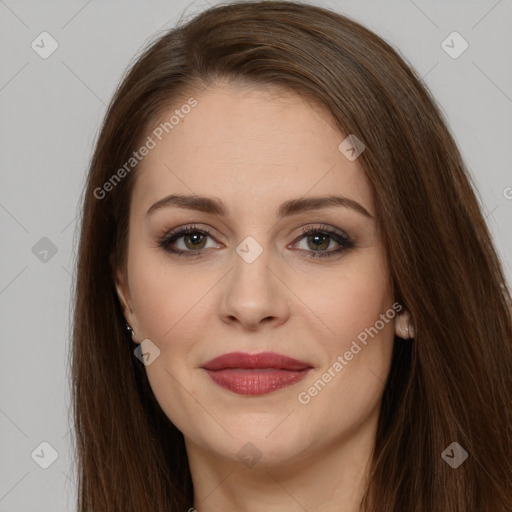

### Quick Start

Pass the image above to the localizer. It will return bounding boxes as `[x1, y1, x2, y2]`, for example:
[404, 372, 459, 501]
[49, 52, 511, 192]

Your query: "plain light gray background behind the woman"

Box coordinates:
[0, 0, 512, 512]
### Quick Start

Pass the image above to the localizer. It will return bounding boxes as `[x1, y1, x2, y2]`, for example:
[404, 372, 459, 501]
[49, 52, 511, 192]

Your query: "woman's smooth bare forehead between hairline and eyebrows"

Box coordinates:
[133, 85, 373, 218]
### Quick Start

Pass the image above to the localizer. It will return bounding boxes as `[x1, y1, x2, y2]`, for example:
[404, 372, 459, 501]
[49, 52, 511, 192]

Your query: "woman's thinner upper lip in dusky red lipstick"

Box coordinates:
[202, 352, 312, 371]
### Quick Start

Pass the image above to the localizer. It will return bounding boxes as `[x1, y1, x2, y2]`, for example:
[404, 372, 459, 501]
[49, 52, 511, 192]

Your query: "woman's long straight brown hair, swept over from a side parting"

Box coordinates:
[71, 1, 512, 512]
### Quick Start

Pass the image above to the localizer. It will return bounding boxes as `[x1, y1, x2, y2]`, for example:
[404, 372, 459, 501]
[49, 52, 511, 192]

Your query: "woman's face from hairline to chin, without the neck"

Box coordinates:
[116, 85, 395, 465]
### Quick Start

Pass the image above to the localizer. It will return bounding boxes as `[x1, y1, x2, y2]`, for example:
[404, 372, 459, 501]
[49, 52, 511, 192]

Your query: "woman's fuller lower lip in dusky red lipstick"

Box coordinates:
[206, 368, 311, 395]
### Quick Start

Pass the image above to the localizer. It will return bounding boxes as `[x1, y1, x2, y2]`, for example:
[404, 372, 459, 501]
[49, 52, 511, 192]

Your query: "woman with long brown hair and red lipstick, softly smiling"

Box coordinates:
[72, 1, 512, 512]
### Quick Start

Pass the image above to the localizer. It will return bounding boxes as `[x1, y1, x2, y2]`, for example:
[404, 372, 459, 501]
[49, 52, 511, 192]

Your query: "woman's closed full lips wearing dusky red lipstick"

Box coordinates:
[202, 352, 313, 395]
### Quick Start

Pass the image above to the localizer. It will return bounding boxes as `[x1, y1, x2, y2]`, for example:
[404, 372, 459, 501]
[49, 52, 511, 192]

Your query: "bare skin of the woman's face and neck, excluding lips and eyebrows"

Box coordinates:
[116, 84, 412, 512]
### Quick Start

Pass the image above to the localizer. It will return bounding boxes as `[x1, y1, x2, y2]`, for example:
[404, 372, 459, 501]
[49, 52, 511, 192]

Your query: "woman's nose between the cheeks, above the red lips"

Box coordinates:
[219, 245, 291, 330]
